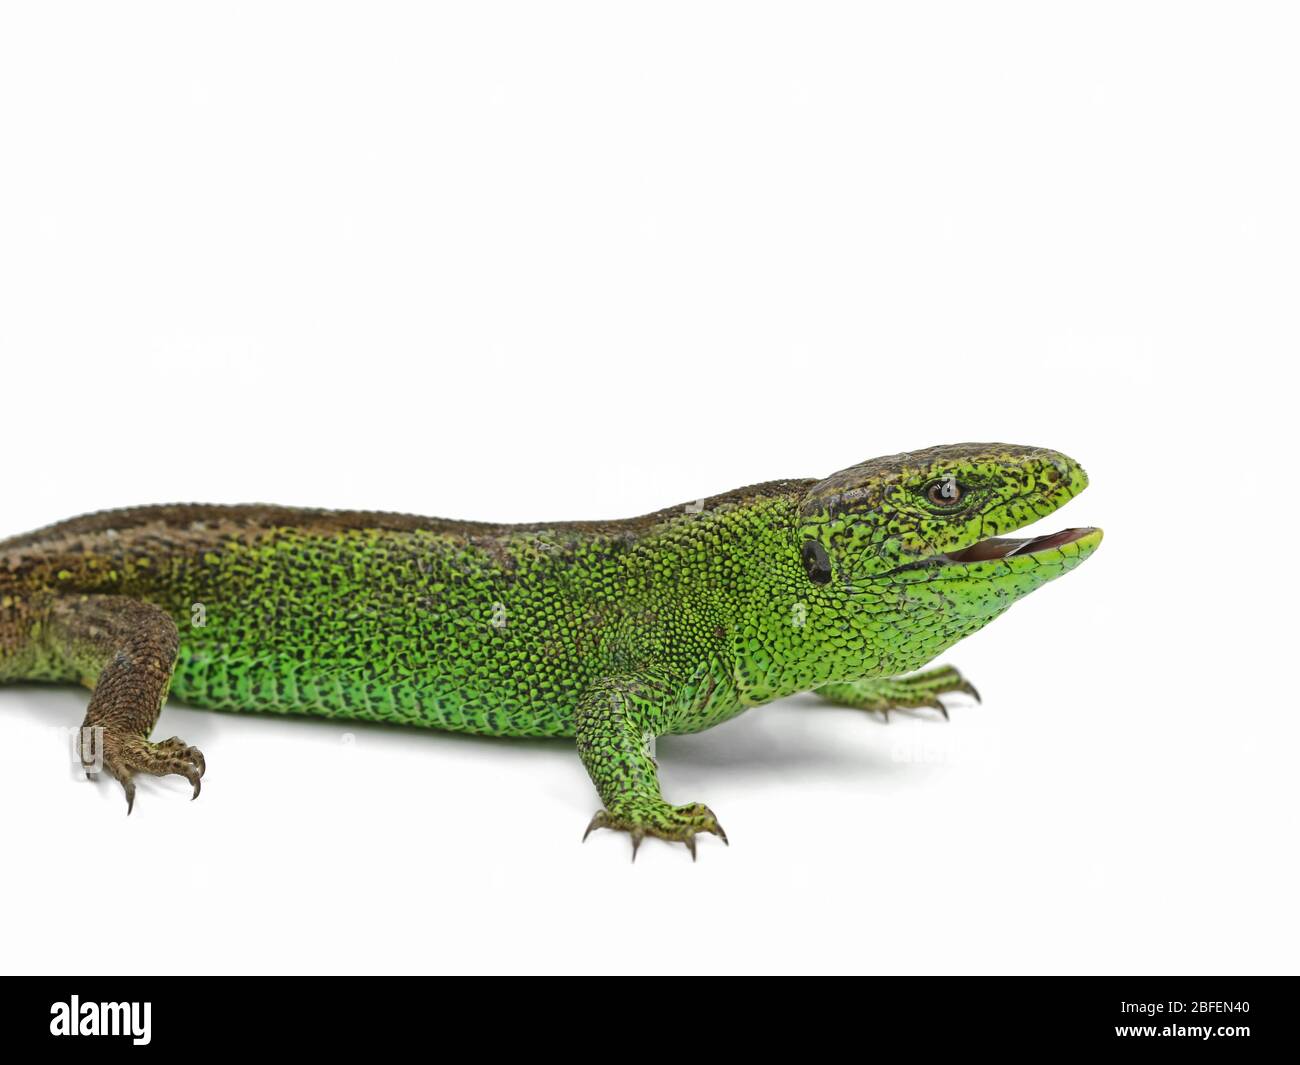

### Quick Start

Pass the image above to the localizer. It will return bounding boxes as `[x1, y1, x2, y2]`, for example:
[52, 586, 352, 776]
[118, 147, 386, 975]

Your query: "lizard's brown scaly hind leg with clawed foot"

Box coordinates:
[49, 596, 204, 813]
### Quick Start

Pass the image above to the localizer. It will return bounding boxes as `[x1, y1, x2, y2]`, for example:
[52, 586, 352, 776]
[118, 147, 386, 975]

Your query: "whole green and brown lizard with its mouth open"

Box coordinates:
[0, 443, 1101, 856]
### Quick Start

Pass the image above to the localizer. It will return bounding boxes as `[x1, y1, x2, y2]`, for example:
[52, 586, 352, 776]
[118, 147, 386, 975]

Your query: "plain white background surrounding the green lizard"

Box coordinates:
[0, 3, 1300, 973]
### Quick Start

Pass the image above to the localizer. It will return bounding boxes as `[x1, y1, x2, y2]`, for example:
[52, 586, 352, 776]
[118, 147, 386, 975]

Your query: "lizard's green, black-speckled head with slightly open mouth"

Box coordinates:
[798, 443, 1101, 667]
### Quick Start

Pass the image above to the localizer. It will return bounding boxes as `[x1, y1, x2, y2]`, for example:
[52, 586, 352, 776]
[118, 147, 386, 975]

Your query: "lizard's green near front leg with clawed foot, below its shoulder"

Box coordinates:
[575, 672, 727, 861]
